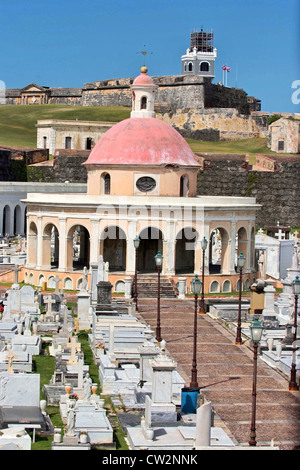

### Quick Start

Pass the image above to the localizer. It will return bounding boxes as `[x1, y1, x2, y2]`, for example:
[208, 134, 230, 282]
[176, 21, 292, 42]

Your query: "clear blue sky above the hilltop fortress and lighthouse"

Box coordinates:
[0, 0, 300, 113]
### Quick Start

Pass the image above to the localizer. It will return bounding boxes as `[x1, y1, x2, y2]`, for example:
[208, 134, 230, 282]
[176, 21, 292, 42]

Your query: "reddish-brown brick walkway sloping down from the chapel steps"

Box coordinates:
[138, 299, 300, 450]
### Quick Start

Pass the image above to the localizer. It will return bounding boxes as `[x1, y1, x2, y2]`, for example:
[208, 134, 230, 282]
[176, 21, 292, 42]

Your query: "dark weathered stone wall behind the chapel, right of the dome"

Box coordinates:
[197, 153, 300, 228]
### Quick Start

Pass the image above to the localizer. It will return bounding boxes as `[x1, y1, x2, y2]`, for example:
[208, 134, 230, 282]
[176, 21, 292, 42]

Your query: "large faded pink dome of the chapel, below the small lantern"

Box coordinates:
[84, 118, 199, 167]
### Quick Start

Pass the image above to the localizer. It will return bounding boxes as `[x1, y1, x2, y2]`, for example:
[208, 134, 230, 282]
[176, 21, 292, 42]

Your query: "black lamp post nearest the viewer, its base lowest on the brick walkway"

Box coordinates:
[249, 317, 264, 446]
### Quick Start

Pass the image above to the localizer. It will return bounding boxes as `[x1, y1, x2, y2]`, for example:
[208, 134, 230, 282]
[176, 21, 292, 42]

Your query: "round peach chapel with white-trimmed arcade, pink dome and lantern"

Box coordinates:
[25, 68, 260, 292]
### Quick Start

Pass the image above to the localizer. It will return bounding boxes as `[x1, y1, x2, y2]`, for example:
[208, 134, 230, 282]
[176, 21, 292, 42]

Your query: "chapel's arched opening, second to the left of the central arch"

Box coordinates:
[67, 225, 90, 271]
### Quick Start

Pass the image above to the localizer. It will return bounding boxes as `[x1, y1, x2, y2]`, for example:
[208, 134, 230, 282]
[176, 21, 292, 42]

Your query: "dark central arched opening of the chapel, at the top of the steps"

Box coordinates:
[138, 227, 163, 273]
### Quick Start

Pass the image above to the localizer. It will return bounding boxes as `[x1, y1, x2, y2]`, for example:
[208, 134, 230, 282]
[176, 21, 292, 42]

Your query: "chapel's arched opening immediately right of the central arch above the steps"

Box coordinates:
[175, 227, 198, 274]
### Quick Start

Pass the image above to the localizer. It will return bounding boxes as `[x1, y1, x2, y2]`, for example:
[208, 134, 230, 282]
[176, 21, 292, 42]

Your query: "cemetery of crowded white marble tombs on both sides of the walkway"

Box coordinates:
[0, 221, 300, 451]
